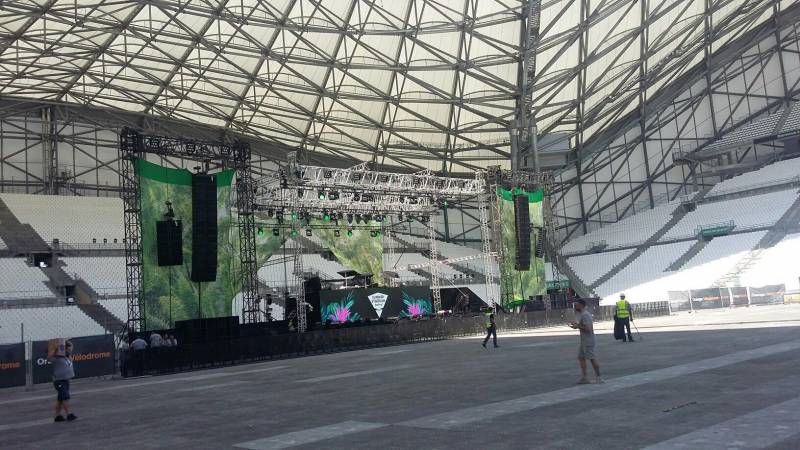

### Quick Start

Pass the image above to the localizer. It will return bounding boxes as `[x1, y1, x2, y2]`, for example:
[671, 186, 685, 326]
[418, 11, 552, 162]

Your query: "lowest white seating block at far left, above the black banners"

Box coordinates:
[0, 306, 105, 344]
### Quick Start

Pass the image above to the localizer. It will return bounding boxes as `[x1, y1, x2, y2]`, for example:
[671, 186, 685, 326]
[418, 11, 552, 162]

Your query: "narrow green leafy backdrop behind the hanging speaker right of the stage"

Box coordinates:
[497, 188, 547, 306]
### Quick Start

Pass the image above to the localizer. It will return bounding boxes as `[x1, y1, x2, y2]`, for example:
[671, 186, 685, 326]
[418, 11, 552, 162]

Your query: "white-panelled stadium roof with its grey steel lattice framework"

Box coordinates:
[0, 0, 800, 250]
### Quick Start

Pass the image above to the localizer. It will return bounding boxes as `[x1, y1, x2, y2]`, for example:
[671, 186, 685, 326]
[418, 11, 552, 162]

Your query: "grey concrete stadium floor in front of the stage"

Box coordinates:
[0, 306, 800, 450]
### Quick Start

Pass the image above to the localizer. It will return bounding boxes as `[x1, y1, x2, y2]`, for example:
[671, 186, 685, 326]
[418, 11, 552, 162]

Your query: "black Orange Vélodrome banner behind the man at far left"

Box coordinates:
[33, 334, 114, 383]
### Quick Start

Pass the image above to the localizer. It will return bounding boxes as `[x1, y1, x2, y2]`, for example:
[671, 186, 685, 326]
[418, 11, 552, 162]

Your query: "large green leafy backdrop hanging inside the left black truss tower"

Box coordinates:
[136, 160, 283, 330]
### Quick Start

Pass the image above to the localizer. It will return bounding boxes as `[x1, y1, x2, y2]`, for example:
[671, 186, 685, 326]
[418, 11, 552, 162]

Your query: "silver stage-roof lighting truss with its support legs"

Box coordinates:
[254, 153, 494, 322]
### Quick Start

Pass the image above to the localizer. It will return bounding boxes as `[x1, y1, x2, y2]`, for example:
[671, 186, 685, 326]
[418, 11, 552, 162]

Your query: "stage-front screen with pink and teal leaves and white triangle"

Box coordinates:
[320, 287, 433, 323]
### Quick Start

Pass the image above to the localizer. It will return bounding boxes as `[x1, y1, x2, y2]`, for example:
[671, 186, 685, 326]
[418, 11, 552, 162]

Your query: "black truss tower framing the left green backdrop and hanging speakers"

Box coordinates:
[119, 128, 260, 331]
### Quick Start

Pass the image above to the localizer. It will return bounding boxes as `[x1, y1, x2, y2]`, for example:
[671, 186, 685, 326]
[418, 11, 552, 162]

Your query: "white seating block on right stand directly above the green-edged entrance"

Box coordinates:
[659, 190, 797, 242]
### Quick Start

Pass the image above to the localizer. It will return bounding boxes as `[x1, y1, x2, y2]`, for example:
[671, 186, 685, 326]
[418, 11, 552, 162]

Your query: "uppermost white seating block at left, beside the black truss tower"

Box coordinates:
[0, 194, 125, 244]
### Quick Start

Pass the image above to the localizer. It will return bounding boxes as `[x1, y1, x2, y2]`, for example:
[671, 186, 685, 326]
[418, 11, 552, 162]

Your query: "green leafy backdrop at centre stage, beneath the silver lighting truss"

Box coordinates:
[311, 219, 383, 284]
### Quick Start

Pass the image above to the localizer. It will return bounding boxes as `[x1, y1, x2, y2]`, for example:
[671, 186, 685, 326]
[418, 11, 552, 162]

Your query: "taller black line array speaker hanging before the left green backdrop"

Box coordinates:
[192, 174, 217, 282]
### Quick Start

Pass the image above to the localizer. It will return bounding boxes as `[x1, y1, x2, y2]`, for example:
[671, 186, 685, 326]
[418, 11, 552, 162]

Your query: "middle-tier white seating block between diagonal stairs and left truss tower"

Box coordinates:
[61, 256, 127, 295]
